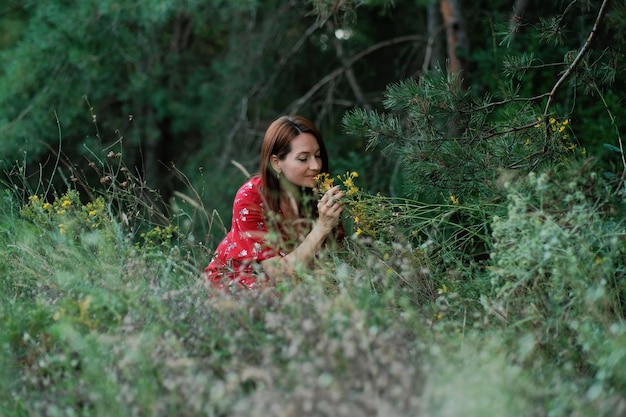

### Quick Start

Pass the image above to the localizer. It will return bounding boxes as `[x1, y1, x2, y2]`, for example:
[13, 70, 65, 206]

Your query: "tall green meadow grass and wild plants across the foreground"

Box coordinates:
[0, 154, 626, 417]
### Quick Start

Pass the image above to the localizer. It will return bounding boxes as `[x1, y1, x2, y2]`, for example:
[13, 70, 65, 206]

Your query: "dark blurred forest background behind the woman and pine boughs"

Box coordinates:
[0, 0, 625, 245]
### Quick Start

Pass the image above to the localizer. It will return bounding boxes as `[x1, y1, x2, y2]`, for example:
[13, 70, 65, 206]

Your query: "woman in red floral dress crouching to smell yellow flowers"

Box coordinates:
[205, 116, 343, 288]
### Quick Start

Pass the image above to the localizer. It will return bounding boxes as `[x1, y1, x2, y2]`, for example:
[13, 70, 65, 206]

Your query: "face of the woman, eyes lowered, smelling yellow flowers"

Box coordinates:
[272, 133, 322, 188]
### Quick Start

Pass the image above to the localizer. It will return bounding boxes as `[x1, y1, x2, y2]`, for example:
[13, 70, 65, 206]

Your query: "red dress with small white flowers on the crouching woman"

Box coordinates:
[204, 176, 285, 288]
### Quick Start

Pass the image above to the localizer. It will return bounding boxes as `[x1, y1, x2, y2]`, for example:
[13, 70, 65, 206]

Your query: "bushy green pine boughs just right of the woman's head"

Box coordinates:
[344, 66, 588, 202]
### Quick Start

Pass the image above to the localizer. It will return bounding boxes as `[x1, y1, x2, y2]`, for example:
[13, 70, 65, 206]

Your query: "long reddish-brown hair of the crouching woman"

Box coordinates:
[260, 116, 329, 213]
